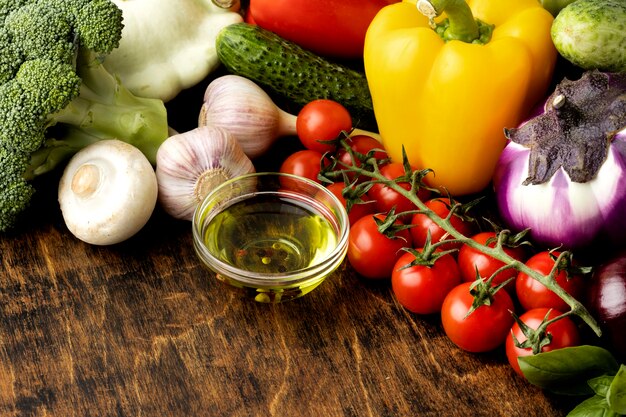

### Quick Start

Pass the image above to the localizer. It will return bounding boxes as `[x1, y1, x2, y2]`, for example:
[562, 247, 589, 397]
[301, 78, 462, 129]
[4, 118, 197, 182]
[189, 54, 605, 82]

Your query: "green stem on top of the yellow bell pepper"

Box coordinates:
[417, 0, 480, 43]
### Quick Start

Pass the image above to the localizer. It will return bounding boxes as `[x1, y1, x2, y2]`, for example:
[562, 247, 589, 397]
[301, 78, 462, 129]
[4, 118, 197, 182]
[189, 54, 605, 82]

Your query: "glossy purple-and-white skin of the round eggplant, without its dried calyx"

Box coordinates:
[493, 70, 626, 255]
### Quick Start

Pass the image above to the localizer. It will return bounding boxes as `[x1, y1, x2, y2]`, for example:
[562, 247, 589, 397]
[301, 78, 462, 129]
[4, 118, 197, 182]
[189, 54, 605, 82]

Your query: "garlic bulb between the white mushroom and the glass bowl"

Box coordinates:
[156, 126, 255, 220]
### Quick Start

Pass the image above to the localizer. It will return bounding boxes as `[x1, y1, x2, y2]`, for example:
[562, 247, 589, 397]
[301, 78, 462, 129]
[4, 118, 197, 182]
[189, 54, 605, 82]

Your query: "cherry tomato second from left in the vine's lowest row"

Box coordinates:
[391, 252, 461, 314]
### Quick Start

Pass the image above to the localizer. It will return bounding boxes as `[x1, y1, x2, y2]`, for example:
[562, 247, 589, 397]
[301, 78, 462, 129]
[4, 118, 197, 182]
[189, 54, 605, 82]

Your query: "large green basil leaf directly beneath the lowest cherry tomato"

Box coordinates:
[518, 345, 619, 395]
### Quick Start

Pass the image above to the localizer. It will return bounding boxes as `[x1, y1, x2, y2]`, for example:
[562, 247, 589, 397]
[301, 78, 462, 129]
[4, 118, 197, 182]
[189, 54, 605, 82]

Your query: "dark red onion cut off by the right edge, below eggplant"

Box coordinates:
[587, 250, 626, 360]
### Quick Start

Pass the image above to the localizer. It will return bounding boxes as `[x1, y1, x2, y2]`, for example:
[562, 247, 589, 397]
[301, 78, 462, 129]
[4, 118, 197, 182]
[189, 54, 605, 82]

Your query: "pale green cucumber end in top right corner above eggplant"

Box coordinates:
[551, 0, 626, 72]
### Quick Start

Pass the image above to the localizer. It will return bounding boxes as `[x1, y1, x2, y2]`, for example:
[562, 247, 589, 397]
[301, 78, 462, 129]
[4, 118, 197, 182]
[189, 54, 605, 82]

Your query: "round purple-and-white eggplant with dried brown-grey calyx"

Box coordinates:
[493, 71, 626, 255]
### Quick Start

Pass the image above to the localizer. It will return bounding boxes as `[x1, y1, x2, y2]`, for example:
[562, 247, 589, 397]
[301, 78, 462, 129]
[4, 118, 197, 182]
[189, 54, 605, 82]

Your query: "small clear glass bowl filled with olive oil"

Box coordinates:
[192, 172, 349, 303]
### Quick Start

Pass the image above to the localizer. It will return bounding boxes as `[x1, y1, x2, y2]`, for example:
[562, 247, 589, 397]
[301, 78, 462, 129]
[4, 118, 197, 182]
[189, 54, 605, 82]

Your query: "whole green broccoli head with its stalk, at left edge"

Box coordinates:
[0, 0, 168, 231]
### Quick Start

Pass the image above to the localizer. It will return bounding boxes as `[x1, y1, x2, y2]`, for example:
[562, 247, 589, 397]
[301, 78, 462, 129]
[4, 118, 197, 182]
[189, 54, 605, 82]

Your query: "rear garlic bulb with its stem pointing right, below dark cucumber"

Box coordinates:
[198, 74, 296, 159]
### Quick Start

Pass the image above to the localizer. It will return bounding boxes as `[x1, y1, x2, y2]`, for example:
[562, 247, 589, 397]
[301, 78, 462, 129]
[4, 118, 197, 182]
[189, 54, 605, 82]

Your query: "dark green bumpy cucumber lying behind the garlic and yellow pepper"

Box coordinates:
[215, 23, 377, 130]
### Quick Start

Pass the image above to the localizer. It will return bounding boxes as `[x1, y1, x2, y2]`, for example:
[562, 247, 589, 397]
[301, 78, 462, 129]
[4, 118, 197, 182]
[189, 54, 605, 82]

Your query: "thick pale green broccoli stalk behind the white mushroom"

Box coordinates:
[24, 50, 168, 180]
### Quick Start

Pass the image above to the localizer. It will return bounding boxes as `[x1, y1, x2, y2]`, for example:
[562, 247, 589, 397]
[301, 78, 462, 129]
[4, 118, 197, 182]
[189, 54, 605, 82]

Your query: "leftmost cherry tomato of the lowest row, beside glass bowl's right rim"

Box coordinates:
[348, 214, 411, 279]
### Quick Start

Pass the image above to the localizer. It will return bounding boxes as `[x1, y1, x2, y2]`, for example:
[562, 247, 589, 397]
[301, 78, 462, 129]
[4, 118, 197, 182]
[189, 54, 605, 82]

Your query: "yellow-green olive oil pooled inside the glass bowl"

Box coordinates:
[204, 194, 338, 274]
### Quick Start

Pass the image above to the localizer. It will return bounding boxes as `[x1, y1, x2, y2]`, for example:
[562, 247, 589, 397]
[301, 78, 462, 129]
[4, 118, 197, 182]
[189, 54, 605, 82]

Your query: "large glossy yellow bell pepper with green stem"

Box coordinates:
[364, 0, 557, 195]
